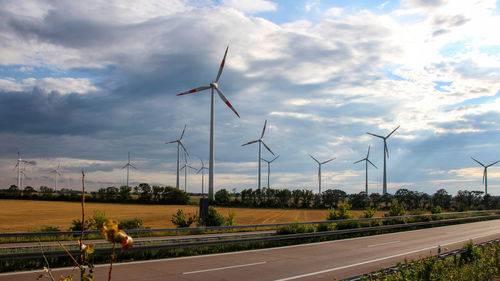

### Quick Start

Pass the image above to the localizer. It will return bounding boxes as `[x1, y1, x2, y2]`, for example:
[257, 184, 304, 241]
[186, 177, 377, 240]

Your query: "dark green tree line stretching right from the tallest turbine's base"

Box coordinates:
[213, 188, 500, 211]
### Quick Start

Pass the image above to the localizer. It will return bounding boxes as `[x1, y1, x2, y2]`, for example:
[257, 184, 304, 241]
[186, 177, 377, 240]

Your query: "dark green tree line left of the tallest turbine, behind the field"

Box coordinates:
[0, 183, 190, 205]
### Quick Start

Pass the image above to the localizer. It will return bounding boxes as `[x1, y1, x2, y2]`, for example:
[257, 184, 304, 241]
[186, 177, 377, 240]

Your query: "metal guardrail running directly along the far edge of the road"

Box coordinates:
[0, 214, 500, 260]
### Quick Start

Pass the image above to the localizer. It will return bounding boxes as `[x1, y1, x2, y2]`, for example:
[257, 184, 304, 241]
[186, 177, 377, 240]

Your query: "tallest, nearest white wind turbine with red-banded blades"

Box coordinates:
[177, 46, 240, 200]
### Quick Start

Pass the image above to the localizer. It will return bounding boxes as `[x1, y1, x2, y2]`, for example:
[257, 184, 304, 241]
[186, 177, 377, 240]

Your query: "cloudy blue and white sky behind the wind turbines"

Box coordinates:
[0, 0, 500, 195]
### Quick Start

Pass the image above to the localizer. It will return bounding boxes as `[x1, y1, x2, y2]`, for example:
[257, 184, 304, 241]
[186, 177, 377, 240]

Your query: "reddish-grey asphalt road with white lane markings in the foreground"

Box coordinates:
[0, 220, 500, 281]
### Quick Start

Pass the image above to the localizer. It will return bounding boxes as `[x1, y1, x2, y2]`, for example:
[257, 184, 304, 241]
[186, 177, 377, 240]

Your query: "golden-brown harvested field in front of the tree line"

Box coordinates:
[0, 199, 383, 233]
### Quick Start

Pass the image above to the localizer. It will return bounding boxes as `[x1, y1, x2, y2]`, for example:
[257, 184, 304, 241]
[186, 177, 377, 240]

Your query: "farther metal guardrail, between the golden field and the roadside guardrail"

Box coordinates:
[0, 210, 500, 238]
